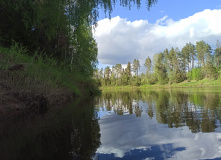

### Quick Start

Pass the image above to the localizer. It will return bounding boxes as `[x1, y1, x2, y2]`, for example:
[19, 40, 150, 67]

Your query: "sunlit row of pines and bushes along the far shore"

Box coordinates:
[94, 40, 221, 86]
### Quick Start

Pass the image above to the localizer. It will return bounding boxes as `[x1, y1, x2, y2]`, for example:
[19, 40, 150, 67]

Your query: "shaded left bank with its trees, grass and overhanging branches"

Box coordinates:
[0, 0, 157, 110]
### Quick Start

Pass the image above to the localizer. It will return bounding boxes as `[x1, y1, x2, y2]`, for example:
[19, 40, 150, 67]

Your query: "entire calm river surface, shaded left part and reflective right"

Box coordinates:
[0, 88, 221, 160]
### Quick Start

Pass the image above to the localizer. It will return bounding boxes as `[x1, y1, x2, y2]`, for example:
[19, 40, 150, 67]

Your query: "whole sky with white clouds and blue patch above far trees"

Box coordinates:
[94, 0, 221, 68]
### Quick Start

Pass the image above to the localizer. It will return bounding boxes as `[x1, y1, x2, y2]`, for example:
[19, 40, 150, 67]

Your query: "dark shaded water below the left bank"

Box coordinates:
[0, 99, 100, 160]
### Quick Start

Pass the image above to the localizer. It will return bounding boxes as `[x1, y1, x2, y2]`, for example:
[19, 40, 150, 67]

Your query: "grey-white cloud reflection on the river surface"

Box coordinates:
[96, 115, 221, 160]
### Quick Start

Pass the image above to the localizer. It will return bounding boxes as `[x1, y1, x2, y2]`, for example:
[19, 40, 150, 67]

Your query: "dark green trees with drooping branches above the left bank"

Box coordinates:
[0, 0, 157, 75]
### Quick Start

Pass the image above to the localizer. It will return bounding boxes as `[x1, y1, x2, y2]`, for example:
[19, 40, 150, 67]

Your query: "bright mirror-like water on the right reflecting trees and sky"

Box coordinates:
[96, 89, 221, 160]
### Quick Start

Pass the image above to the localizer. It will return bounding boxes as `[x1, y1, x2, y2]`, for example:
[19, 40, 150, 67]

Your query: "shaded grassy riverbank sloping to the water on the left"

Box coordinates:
[0, 45, 97, 118]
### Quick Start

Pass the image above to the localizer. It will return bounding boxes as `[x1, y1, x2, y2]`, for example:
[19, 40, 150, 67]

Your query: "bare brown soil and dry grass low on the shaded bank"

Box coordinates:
[0, 68, 74, 119]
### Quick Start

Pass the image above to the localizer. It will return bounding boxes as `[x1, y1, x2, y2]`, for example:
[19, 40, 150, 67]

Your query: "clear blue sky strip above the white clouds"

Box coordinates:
[99, 0, 221, 23]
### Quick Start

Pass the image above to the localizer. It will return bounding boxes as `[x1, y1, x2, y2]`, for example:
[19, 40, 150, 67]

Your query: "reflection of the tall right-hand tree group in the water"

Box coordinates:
[148, 90, 219, 133]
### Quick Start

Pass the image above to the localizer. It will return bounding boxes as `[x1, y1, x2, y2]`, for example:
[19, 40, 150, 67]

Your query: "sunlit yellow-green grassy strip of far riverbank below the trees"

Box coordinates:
[100, 79, 221, 90]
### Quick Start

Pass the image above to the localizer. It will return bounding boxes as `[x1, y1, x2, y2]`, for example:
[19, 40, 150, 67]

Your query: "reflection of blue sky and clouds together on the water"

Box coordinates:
[94, 89, 221, 160]
